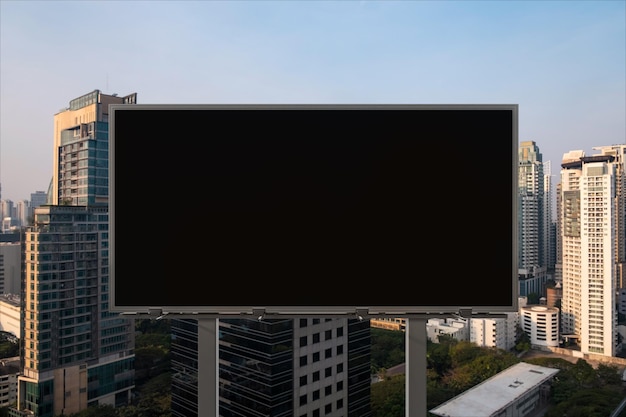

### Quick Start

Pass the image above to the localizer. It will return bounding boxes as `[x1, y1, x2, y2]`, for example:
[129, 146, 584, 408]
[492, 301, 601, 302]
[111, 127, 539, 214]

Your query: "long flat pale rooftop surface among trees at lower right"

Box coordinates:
[430, 362, 559, 417]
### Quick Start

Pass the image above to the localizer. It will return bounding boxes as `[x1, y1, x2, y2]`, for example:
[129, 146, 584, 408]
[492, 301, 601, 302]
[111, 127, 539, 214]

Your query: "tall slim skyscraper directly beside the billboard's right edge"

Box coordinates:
[518, 141, 550, 296]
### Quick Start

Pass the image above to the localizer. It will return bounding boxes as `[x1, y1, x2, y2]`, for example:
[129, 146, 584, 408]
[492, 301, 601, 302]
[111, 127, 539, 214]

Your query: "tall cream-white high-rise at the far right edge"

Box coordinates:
[560, 145, 626, 356]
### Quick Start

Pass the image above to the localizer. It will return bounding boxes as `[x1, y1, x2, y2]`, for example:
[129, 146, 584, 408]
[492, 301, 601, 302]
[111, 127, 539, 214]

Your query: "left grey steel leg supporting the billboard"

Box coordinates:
[198, 318, 219, 417]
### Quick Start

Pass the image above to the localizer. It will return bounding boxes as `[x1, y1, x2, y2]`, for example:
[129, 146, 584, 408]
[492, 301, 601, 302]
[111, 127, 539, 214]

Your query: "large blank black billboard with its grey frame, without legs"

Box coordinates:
[109, 104, 518, 316]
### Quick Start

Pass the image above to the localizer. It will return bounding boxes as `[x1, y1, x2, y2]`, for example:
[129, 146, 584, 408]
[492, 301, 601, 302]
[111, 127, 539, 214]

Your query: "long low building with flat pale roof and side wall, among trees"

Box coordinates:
[429, 362, 559, 417]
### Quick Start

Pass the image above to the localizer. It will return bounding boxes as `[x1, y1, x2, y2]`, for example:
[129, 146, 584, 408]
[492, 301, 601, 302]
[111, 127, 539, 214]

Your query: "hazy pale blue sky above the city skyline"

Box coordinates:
[0, 0, 626, 201]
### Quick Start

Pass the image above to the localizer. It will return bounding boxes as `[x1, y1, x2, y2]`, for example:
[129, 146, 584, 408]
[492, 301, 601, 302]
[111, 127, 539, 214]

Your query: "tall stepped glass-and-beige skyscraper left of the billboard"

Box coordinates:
[10, 90, 136, 417]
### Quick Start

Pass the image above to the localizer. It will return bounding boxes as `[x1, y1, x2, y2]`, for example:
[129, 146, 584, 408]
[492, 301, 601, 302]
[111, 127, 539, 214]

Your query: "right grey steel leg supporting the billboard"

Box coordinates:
[405, 317, 427, 417]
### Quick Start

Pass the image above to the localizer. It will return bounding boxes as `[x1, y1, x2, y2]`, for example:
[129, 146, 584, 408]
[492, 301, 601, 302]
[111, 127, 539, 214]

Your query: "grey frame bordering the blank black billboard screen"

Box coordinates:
[109, 104, 519, 319]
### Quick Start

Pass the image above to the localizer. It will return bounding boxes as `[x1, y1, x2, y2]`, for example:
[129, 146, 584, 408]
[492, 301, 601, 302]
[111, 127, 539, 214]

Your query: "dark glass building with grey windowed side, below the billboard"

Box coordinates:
[172, 317, 371, 417]
